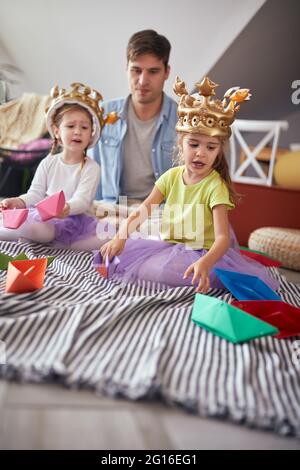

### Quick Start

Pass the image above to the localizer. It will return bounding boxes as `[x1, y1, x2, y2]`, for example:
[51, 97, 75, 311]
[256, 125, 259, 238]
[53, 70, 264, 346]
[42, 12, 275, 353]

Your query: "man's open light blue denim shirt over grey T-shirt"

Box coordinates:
[89, 94, 177, 202]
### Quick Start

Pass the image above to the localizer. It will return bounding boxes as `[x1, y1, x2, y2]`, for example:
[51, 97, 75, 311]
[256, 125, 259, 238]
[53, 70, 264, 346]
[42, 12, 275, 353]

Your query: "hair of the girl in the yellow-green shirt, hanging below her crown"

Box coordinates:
[174, 132, 240, 204]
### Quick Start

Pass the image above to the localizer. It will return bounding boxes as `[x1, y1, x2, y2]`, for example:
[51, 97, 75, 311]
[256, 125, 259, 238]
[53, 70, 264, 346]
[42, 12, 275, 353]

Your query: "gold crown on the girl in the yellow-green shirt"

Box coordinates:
[173, 77, 251, 139]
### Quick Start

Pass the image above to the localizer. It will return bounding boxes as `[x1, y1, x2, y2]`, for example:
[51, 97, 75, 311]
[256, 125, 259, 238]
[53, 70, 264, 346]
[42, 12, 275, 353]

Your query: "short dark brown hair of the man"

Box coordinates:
[127, 29, 171, 68]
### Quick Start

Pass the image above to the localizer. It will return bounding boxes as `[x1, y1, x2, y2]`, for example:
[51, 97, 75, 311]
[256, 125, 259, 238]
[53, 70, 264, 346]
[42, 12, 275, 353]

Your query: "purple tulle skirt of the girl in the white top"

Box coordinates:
[27, 208, 98, 246]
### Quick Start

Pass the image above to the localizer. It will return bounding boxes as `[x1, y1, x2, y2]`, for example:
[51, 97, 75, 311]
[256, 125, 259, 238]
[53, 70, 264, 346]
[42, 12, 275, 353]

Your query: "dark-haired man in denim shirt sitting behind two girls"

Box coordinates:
[92, 30, 177, 202]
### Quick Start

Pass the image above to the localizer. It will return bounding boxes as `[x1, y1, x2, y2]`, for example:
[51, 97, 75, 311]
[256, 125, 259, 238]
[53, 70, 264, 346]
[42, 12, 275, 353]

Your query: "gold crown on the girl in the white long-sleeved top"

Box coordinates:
[46, 83, 119, 147]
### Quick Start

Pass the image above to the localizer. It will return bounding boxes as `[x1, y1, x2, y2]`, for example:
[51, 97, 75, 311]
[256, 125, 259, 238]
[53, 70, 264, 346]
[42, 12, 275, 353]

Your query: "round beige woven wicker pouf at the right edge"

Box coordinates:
[248, 227, 300, 271]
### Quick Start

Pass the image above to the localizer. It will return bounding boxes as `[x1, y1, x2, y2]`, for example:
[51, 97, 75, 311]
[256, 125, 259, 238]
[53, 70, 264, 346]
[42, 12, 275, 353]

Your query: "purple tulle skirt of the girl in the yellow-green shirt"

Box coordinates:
[112, 239, 279, 289]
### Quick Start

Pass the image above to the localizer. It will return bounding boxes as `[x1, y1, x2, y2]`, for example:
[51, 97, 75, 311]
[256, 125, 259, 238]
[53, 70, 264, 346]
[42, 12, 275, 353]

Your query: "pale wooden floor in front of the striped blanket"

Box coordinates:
[0, 270, 300, 450]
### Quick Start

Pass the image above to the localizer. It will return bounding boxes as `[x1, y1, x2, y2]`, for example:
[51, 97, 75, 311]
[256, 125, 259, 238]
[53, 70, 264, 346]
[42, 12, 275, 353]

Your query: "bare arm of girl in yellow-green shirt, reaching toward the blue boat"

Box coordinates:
[183, 204, 230, 294]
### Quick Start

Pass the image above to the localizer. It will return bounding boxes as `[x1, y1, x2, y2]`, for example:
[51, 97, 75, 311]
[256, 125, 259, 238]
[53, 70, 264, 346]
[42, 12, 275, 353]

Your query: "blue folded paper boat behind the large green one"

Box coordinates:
[214, 268, 281, 300]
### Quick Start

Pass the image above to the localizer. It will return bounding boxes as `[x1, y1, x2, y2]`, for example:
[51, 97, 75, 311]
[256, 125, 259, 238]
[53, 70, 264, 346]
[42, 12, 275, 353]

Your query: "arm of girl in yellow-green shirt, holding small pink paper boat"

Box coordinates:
[100, 186, 165, 260]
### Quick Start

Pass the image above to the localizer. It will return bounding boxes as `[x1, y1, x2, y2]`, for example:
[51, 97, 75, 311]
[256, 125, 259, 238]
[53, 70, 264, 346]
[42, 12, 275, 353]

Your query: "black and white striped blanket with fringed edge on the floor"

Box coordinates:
[0, 242, 300, 436]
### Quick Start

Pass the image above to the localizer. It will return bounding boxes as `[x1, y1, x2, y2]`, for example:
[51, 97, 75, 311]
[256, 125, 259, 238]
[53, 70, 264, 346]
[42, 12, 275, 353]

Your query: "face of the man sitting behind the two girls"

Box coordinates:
[127, 54, 170, 104]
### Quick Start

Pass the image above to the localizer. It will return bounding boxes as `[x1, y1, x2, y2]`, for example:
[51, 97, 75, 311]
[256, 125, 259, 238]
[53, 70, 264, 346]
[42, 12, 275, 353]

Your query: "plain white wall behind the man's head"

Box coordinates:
[0, 0, 265, 99]
